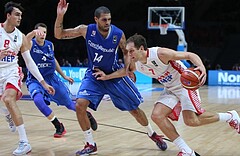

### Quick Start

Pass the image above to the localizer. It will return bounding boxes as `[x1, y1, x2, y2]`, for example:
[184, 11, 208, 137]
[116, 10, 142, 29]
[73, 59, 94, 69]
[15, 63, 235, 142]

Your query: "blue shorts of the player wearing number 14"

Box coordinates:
[77, 71, 143, 111]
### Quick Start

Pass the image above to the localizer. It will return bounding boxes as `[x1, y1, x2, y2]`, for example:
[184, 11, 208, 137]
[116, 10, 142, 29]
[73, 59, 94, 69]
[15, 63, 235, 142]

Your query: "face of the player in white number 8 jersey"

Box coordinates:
[7, 7, 22, 27]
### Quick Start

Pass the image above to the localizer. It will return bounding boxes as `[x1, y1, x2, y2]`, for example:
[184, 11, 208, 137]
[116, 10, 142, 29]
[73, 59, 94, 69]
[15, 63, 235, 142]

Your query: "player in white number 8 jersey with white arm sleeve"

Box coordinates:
[0, 2, 55, 155]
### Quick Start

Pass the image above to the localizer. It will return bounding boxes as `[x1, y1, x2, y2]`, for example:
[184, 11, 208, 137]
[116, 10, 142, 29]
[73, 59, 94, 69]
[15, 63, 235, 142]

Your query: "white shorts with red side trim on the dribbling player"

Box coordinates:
[156, 88, 205, 120]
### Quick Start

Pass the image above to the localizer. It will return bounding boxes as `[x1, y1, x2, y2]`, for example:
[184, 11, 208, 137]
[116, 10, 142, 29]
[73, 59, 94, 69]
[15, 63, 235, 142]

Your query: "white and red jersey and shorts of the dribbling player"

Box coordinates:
[136, 47, 205, 120]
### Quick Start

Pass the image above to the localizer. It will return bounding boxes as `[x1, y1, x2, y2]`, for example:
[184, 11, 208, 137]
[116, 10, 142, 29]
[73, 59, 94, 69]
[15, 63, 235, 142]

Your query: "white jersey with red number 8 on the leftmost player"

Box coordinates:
[0, 23, 23, 68]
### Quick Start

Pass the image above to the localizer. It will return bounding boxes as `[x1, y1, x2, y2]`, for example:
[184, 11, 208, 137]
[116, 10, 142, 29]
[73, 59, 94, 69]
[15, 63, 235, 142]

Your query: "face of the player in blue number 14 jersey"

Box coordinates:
[95, 13, 111, 32]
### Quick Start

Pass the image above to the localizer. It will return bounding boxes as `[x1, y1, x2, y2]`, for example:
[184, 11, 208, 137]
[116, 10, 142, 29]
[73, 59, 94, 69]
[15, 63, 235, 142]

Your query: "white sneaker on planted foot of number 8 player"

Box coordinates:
[13, 141, 32, 156]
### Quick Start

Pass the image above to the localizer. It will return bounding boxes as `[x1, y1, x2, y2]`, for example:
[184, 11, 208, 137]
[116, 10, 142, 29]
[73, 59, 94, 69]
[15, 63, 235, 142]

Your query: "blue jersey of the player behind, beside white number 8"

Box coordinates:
[28, 39, 56, 79]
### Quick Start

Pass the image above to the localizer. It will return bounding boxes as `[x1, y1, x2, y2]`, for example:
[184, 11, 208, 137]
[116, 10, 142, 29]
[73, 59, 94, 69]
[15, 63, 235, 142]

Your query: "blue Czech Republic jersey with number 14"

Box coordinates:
[86, 24, 123, 74]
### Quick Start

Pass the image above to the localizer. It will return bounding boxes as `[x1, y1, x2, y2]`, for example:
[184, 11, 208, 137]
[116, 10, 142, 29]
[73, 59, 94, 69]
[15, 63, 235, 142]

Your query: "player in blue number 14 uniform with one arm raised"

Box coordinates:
[54, 0, 167, 155]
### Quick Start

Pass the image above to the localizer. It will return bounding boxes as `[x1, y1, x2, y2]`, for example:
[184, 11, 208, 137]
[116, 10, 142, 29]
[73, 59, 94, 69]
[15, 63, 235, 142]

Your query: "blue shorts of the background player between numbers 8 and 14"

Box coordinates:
[26, 73, 73, 106]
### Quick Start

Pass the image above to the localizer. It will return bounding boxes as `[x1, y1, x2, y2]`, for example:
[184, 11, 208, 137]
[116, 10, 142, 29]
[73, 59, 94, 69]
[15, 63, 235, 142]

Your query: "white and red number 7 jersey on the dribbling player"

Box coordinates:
[135, 47, 187, 91]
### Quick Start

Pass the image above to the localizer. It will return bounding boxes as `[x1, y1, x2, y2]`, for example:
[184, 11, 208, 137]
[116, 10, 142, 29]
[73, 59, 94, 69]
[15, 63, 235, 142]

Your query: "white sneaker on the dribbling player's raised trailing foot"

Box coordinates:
[227, 110, 240, 134]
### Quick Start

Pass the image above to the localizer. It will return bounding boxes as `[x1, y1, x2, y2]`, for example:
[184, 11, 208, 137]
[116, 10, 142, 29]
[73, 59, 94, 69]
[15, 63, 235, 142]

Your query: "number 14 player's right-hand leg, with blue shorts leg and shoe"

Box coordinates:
[108, 76, 167, 150]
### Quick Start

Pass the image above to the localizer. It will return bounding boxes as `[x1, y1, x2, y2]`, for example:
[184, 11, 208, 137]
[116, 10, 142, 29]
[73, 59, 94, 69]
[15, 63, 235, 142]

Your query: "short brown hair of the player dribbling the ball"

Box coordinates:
[126, 34, 147, 50]
